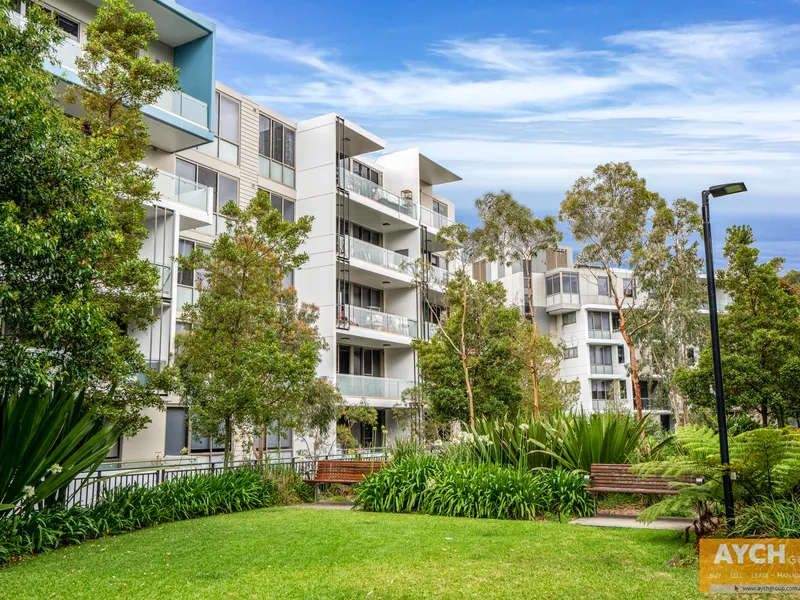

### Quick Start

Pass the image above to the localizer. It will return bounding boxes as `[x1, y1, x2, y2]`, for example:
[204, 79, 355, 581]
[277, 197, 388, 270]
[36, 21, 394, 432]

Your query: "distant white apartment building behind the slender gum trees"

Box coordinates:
[482, 247, 729, 429]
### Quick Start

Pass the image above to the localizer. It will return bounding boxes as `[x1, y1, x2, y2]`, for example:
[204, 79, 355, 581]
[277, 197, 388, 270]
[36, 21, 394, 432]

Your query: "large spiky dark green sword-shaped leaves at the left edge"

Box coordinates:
[0, 382, 120, 513]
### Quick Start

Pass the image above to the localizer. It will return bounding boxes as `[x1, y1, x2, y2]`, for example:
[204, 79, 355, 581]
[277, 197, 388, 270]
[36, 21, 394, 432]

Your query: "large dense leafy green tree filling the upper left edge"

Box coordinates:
[0, 1, 174, 433]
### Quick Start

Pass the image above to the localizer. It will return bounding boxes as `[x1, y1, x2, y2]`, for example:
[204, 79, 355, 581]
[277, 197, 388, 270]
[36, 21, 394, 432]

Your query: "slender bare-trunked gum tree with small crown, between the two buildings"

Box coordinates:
[474, 192, 564, 419]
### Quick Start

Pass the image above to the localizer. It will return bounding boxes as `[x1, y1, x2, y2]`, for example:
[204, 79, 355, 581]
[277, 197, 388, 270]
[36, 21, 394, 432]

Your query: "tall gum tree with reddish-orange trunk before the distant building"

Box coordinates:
[559, 163, 676, 420]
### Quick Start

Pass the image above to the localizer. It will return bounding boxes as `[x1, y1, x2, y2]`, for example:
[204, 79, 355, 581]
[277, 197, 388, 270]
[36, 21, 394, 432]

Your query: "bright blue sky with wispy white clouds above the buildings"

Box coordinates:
[180, 0, 800, 268]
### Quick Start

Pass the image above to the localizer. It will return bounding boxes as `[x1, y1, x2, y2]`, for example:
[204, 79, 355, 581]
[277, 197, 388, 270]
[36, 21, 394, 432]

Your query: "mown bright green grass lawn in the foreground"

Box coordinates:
[0, 508, 703, 600]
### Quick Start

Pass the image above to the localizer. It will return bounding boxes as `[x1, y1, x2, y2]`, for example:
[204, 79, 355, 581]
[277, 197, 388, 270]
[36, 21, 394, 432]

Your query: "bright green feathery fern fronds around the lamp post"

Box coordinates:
[635, 425, 800, 521]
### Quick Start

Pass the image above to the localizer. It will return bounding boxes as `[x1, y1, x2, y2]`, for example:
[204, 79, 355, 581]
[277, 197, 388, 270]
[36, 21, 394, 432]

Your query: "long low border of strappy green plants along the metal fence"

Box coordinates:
[0, 469, 294, 564]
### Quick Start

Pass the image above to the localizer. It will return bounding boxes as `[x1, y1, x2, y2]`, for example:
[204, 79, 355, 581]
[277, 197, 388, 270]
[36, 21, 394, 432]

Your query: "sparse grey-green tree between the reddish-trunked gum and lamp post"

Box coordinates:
[636, 198, 708, 425]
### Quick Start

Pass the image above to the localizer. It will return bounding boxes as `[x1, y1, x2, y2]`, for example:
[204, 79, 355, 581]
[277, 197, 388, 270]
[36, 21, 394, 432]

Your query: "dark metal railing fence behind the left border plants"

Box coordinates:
[61, 448, 386, 507]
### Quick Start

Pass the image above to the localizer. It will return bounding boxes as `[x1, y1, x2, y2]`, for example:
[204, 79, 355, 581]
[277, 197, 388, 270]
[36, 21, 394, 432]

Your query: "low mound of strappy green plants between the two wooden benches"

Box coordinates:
[356, 454, 591, 519]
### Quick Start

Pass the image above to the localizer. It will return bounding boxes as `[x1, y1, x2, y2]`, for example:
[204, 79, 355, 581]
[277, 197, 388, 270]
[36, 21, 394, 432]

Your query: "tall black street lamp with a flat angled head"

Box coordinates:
[703, 182, 747, 529]
